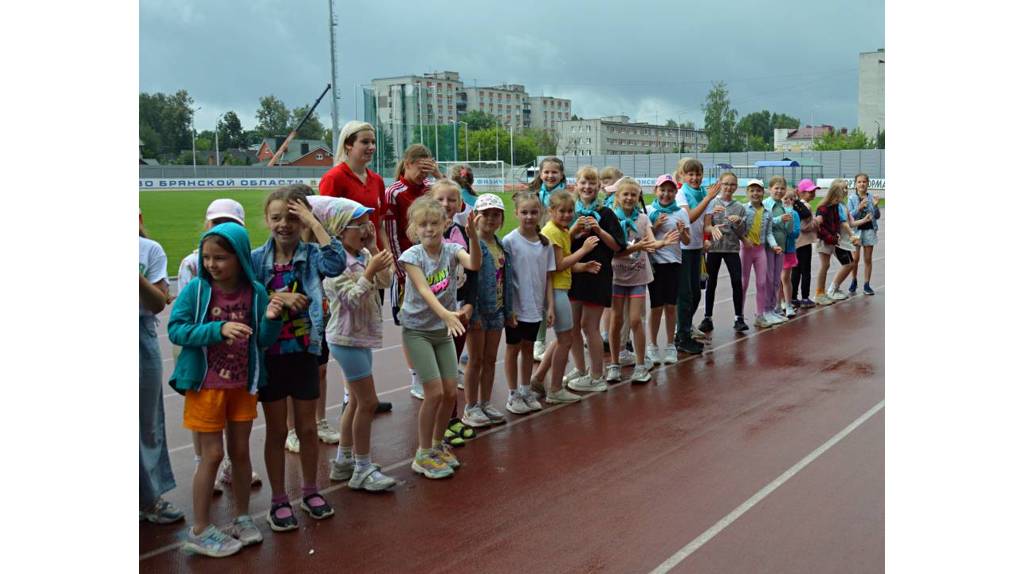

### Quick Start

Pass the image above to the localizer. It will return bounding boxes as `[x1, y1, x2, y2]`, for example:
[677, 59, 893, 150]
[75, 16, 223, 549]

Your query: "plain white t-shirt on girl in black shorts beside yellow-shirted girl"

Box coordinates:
[502, 228, 555, 323]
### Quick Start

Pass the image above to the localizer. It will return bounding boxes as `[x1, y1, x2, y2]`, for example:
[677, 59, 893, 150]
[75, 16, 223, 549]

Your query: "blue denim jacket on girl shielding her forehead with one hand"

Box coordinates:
[252, 236, 345, 355]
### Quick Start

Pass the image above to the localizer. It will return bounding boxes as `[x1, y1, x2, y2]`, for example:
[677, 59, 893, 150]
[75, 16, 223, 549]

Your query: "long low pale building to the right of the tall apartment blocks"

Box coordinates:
[557, 116, 708, 156]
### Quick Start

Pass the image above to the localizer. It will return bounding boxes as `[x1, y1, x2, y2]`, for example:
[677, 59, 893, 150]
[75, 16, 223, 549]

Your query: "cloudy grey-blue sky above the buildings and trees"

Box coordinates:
[139, 0, 885, 136]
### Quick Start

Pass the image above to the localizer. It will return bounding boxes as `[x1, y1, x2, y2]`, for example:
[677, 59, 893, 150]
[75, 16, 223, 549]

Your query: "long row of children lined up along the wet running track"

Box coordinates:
[134, 125, 880, 557]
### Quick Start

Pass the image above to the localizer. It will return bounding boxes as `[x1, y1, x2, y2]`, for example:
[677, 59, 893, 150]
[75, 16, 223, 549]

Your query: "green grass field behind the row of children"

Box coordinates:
[138, 189, 885, 276]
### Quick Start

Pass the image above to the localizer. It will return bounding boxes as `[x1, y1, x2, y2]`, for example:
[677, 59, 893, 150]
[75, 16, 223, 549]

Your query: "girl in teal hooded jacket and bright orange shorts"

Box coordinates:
[167, 223, 283, 558]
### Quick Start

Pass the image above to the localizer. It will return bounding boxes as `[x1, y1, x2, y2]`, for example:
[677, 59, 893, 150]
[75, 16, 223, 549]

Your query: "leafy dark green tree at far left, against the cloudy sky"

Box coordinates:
[138, 90, 194, 157]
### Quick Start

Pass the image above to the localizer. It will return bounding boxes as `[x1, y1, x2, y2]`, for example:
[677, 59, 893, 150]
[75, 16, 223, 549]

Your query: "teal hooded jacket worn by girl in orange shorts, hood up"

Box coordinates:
[167, 223, 282, 395]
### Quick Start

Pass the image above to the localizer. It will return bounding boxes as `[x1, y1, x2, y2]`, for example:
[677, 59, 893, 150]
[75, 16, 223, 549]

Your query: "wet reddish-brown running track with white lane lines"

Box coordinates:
[139, 226, 886, 573]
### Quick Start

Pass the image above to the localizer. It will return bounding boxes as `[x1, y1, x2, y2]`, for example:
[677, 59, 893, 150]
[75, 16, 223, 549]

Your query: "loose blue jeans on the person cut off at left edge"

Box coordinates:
[138, 316, 175, 509]
